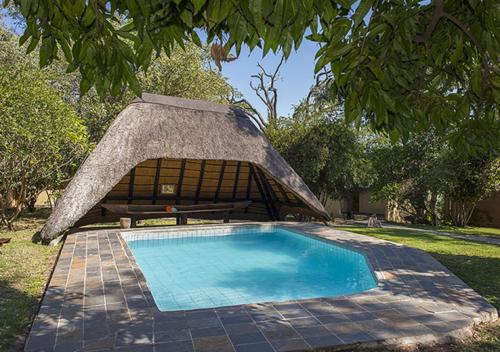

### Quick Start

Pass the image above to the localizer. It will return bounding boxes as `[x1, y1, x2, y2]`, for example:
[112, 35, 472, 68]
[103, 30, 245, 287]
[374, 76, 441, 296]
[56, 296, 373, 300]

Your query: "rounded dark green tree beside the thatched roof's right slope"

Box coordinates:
[266, 104, 371, 199]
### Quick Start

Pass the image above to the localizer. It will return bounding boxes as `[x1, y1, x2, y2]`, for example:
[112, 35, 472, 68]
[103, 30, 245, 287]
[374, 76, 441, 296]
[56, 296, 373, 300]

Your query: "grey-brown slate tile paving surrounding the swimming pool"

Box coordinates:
[25, 223, 497, 352]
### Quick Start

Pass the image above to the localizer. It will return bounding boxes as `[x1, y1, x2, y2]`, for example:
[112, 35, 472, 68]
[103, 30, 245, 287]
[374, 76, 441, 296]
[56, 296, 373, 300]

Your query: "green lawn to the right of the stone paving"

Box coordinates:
[340, 226, 500, 352]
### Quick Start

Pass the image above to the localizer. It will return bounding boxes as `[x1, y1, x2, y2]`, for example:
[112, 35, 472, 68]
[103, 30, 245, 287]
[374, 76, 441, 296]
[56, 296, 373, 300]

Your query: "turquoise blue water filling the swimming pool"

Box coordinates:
[125, 227, 376, 311]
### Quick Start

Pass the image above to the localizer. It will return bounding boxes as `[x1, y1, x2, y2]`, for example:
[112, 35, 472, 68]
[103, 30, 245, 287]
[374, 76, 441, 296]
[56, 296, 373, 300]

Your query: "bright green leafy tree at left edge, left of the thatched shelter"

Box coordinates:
[0, 67, 88, 229]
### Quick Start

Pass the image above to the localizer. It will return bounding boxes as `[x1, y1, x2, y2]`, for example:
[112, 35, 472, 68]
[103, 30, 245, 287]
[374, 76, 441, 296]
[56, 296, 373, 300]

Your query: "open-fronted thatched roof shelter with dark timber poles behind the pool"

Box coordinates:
[41, 94, 329, 240]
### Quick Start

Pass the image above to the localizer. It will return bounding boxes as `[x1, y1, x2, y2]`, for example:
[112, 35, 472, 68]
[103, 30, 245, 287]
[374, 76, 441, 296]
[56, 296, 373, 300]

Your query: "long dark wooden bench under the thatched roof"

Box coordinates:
[101, 201, 251, 227]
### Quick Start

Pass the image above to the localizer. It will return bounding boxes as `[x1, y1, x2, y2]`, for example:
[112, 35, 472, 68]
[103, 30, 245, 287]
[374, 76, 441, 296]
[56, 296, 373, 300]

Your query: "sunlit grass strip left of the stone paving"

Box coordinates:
[0, 211, 59, 351]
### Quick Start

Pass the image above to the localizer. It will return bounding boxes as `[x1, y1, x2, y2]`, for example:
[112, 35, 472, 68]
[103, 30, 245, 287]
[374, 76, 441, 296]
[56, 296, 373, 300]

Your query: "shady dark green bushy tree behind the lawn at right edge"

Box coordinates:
[370, 132, 500, 226]
